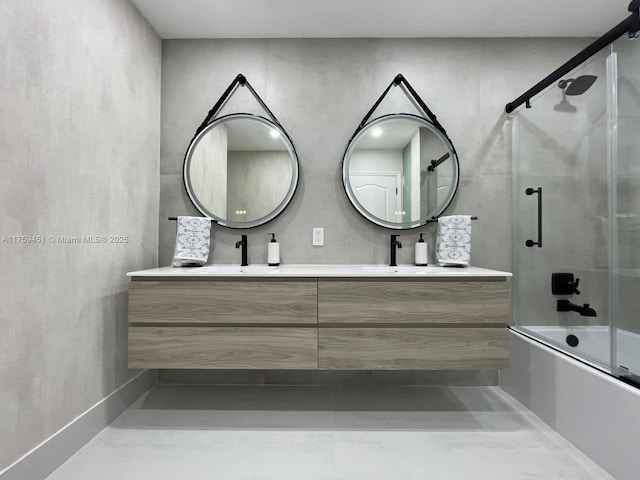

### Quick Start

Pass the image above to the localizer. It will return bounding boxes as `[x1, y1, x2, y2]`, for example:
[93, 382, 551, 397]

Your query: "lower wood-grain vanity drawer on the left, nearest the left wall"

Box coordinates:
[129, 326, 318, 369]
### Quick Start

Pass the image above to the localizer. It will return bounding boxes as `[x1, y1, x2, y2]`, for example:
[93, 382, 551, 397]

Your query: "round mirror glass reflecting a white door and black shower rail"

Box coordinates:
[342, 114, 458, 229]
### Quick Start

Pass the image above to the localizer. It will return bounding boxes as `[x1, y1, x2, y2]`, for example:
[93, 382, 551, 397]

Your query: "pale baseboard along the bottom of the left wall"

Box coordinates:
[0, 370, 157, 480]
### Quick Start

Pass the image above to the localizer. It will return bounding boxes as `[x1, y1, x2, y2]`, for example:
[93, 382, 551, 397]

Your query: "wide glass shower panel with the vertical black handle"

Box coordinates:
[513, 49, 610, 368]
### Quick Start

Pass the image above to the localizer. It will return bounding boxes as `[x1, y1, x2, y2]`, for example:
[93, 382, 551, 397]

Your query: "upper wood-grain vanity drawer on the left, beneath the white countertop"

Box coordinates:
[129, 279, 317, 325]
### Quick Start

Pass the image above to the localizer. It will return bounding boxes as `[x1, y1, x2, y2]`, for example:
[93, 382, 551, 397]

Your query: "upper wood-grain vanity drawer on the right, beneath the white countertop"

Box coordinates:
[318, 279, 510, 325]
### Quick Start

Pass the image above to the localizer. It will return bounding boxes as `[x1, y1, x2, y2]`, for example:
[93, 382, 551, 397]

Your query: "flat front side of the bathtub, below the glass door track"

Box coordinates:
[500, 331, 640, 480]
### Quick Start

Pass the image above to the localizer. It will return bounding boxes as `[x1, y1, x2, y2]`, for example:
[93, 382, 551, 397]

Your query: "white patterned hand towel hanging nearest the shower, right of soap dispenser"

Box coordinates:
[436, 215, 471, 267]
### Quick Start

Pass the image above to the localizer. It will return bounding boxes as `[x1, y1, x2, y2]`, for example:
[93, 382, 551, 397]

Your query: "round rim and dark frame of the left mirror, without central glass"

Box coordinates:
[182, 113, 300, 229]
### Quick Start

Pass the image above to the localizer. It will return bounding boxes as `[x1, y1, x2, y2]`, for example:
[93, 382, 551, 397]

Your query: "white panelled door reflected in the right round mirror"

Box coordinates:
[350, 172, 402, 222]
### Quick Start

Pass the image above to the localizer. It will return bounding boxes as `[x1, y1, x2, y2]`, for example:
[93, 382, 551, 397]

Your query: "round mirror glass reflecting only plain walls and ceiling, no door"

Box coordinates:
[184, 113, 298, 228]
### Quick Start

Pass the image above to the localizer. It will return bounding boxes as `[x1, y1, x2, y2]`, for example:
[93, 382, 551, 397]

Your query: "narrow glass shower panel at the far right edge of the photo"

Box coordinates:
[611, 38, 640, 381]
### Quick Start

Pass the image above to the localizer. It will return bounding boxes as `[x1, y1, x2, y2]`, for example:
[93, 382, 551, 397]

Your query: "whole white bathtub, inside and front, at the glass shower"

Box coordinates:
[499, 327, 640, 480]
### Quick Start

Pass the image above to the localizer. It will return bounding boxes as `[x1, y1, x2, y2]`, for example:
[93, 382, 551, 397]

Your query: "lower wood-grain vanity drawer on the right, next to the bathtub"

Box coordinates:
[318, 327, 508, 370]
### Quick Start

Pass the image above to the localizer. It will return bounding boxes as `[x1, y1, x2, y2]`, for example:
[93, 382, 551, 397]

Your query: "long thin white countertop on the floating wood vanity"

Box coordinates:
[127, 265, 512, 278]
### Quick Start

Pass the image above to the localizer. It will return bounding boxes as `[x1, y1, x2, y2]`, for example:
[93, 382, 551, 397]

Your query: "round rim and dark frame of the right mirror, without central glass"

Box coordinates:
[342, 113, 460, 230]
